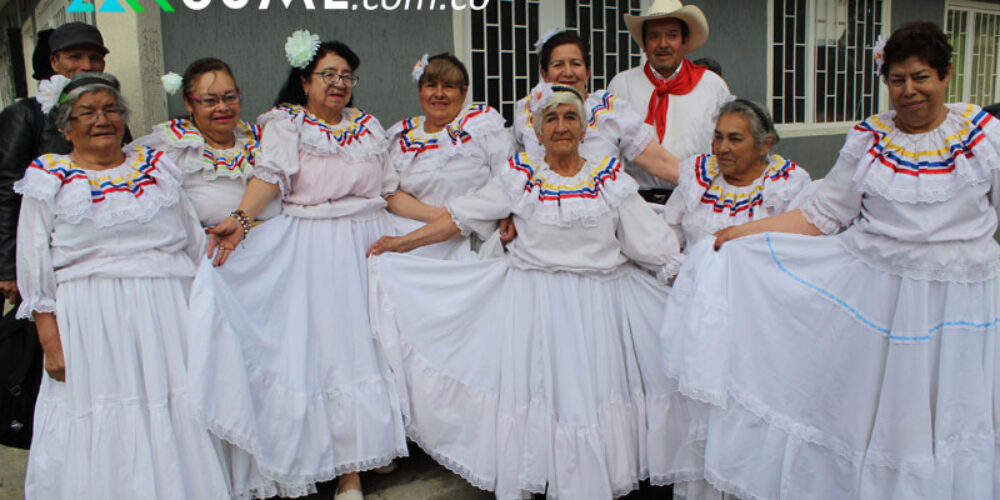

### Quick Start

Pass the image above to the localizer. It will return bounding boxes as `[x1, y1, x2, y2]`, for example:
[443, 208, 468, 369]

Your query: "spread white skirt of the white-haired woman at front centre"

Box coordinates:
[371, 254, 667, 500]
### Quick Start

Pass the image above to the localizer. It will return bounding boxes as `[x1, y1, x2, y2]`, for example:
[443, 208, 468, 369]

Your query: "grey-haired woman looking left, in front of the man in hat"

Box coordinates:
[663, 99, 810, 252]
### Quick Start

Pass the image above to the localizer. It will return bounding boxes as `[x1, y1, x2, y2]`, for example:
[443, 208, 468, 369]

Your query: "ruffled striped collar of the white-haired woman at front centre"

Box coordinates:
[498, 153, 639, 227]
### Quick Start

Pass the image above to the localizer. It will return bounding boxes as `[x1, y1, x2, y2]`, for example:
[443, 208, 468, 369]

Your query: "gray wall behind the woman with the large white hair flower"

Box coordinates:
[162, 6, 454, 128]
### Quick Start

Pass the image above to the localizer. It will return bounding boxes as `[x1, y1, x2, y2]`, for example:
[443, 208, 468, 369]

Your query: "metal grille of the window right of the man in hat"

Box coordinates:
[770, 0, 886, 124]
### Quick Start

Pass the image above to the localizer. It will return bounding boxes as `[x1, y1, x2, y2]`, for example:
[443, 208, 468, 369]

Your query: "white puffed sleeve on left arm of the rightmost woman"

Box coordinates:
[801, 134, 870, 234]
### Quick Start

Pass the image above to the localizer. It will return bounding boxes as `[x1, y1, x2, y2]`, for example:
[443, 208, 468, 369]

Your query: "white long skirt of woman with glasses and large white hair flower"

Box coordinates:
[190, 211, 406, 497]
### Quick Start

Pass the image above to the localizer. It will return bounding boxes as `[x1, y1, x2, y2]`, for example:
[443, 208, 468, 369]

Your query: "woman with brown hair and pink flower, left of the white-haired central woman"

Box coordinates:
[388, 53, 513, 259]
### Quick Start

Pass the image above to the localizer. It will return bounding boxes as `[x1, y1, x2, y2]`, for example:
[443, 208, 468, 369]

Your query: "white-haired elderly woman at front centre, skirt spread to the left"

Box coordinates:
[371, 86, 679, 500]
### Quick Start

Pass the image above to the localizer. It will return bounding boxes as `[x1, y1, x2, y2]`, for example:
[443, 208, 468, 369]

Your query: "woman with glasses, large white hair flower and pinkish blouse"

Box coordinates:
[189, 31, 406, 500]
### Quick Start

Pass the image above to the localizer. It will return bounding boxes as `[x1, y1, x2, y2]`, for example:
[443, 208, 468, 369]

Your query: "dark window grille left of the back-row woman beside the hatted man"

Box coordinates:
[471, 0, 539, 124]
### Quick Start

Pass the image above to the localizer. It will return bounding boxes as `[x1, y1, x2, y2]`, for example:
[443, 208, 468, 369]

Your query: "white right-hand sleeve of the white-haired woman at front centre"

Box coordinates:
[616, 193, 684, 282]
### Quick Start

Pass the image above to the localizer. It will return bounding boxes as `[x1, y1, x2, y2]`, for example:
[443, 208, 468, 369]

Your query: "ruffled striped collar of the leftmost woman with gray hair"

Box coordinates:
[14, 146, 181, 227]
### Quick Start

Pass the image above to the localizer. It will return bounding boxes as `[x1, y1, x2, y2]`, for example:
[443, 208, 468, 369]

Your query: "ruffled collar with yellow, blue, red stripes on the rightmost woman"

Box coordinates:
[845, 104, 1000, 203]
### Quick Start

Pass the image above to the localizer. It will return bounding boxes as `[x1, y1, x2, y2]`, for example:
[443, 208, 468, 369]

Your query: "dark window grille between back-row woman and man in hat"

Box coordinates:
[566, 0, 642, 90]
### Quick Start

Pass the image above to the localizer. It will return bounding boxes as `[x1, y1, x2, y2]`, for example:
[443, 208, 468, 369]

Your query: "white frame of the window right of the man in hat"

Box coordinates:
[766, 0, 892, 137]
